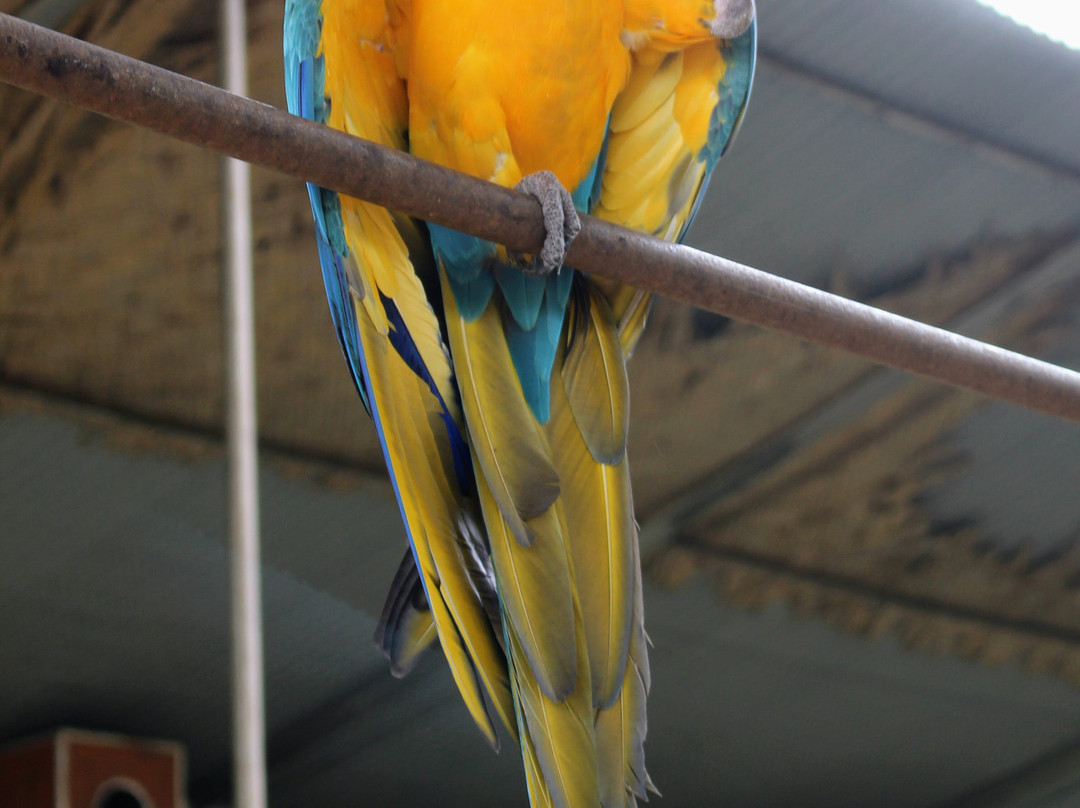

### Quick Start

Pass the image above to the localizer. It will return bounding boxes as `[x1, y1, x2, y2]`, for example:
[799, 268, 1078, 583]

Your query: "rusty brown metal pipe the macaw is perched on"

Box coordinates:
[0, 14, 1080, 421]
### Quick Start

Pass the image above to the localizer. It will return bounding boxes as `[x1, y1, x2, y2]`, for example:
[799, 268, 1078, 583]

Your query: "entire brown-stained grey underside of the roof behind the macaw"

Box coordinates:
[6, 0, 1080, 808]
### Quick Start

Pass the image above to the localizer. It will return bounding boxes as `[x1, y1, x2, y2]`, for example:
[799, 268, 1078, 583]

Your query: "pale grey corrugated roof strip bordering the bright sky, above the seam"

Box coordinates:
[758, 0, 1080, 173]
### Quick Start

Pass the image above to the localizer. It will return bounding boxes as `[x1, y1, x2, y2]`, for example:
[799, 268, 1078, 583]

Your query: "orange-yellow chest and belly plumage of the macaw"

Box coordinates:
[402, 0, 630, 188]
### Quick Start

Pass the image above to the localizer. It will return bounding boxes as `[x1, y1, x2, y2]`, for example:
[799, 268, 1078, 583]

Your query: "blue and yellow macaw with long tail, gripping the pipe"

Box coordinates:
[285, 0, 755, 808]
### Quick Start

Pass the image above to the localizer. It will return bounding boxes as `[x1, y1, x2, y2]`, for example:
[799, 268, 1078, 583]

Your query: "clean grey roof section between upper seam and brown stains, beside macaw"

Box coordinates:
[690, 63, 1080, 289]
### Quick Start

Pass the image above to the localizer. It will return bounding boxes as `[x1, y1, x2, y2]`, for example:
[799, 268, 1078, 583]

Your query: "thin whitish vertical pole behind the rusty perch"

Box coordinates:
[218, 0, 267, 808]
